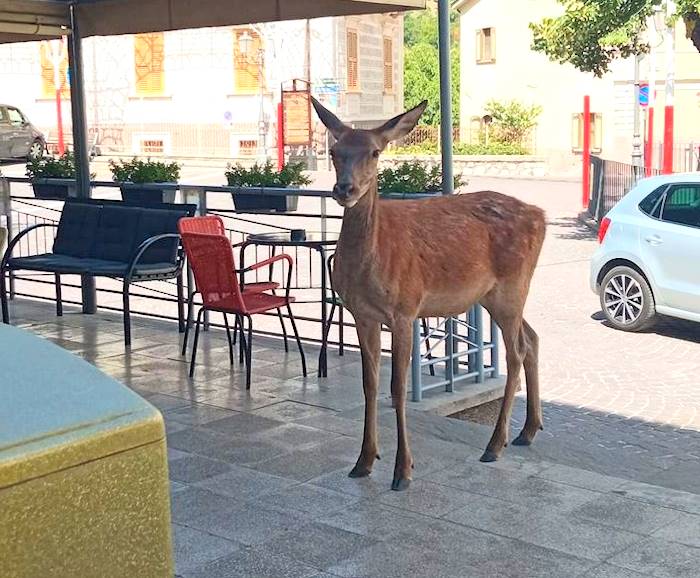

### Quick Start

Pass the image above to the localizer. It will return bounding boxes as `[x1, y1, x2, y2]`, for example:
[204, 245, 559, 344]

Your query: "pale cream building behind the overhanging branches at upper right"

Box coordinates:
[456, 0, 700, 171]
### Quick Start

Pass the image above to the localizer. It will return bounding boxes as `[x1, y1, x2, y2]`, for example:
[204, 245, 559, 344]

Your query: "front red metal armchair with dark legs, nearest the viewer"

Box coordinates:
[179, 217, 306, 389]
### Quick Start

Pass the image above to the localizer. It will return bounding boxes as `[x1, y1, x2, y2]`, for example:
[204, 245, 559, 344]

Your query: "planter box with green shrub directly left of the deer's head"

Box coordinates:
[226, 161, 311, 212]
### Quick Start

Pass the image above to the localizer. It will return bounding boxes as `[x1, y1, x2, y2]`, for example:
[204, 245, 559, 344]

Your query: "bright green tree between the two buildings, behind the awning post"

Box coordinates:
[404, 2, 459, 126]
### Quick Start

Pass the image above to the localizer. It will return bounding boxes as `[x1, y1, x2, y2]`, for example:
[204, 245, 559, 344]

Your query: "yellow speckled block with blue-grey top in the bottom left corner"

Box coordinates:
[0, 326, 173, 578]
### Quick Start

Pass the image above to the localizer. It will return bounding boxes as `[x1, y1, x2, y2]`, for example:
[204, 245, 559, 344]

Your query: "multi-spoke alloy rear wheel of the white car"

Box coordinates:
[599, 265, 656, 331]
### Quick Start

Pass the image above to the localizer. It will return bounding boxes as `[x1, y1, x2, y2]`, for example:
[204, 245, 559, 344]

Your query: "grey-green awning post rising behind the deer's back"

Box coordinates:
[438, 0, 454, 195]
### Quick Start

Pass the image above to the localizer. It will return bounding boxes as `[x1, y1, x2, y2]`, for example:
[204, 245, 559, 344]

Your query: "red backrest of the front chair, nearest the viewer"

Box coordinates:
[180, 228, 246, 313]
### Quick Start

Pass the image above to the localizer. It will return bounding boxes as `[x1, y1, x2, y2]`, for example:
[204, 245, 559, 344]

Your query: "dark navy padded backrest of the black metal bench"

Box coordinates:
[53, 200, 196, 264]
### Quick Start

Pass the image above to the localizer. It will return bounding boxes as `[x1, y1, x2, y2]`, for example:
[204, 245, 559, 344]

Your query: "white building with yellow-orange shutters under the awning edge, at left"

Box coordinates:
[0, 15, 403, 157]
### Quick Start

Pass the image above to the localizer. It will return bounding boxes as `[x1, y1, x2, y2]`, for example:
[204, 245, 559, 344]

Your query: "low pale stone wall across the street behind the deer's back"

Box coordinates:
[379, 155, 549, 177]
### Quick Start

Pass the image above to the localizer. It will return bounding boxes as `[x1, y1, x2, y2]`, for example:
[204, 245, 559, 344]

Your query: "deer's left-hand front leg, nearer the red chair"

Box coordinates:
[348, 320, 381, 478]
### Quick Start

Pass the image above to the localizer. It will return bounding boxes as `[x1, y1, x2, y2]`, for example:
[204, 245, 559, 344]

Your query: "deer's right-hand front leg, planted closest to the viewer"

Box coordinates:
[391, 321, 413, 491]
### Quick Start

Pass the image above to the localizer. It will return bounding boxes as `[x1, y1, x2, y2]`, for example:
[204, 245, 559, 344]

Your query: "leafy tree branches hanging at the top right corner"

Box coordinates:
[530, 0, 700, 76]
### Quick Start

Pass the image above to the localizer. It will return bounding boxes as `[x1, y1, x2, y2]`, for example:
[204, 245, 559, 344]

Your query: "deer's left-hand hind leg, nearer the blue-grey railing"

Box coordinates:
[480, 316, 526, 462]
